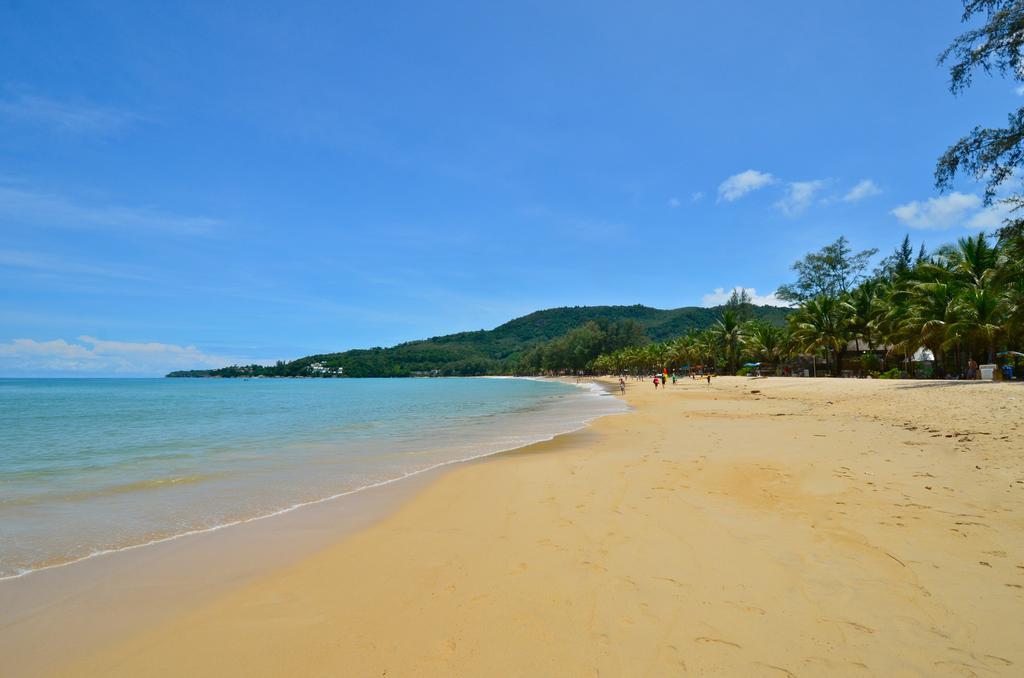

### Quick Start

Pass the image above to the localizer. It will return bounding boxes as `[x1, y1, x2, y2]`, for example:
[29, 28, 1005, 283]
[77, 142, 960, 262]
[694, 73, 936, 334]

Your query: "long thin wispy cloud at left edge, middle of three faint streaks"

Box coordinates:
[0, 185, 222, 236]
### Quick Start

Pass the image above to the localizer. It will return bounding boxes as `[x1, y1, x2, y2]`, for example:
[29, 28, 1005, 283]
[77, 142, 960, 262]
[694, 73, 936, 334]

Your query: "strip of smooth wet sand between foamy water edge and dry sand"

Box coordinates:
[0, 377, 628, 675]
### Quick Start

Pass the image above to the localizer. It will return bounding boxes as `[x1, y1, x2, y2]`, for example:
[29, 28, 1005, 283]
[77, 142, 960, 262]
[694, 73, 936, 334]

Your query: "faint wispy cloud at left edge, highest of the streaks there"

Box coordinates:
[0, 94, 139, 134]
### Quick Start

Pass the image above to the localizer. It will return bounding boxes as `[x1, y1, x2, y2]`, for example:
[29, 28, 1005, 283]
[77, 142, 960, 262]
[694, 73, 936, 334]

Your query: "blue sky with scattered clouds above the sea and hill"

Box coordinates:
[0, 0, 1021, 376]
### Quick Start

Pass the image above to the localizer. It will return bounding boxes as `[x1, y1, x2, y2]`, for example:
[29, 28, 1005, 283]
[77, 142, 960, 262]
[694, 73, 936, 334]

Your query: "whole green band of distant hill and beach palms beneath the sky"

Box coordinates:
[169, 229, 1024, 377]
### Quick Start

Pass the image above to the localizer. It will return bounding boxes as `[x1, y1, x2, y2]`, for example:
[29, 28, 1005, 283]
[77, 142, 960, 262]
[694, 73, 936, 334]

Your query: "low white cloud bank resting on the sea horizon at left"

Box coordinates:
[0, 336, 238, 376]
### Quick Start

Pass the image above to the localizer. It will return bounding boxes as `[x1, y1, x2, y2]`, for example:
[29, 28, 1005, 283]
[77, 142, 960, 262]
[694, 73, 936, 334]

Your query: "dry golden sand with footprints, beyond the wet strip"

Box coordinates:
[14, 377, 1024, 676]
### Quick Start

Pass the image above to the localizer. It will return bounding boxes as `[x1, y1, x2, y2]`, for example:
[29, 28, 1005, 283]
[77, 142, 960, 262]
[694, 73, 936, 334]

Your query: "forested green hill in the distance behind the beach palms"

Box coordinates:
[167, 304, 790, 377]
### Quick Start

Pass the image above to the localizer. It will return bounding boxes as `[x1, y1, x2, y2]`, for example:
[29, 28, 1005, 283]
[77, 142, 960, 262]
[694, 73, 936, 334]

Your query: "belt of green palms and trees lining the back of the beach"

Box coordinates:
[590, 231, 1024, 377]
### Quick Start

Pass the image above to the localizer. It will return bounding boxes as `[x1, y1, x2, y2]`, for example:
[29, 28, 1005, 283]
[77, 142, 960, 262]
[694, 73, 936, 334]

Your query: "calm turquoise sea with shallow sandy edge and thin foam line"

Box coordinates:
[0, 379, 625, 579]
